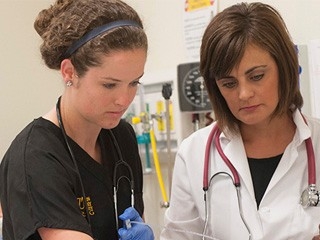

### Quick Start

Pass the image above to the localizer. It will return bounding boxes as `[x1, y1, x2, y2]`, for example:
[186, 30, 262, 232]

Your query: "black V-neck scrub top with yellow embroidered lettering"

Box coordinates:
[0, 118, 144, 240]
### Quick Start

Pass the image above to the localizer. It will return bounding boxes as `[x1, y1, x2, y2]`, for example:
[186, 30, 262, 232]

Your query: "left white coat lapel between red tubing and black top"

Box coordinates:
[220, 134, 255, 199]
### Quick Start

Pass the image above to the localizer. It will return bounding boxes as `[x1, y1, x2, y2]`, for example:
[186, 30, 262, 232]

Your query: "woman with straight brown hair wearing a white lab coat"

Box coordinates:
[160, 3, 320, 240]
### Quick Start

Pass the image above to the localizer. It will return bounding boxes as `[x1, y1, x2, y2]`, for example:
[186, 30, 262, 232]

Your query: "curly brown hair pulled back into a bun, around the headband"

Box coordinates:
[34, 0, 148, 77]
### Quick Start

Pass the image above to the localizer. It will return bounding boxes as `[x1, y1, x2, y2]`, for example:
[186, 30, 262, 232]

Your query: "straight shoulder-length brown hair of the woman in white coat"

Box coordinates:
[200, 3, 303, 133]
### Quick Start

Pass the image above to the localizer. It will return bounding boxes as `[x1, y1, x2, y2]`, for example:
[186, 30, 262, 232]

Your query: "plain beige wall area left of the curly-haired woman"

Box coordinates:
[0, 0, 61, 158]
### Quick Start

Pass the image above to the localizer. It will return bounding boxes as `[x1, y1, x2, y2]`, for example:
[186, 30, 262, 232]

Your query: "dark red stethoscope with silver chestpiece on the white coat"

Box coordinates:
[203, 122, 320, 207]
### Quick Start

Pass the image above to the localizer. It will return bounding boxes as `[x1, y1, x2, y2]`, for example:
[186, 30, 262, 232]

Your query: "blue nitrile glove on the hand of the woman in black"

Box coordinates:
[118, 207, 154, 240]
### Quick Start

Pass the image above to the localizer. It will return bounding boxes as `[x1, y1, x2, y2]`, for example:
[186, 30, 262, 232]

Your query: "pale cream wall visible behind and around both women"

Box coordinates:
[0, 0, 320, 159]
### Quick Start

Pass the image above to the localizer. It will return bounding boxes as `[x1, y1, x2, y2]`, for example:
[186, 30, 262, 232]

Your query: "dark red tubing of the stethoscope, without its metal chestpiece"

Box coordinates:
[203, 124, 316, 191]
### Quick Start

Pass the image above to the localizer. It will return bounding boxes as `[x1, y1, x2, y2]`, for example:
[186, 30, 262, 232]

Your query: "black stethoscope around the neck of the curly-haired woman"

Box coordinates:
[56, 97, 134, 229]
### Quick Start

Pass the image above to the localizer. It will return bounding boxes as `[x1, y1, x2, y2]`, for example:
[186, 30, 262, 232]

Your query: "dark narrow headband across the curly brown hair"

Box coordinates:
[64, 20, 141, 58]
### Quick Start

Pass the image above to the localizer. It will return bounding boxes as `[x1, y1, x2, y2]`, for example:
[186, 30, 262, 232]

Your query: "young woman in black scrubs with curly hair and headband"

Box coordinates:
[0, 0, 154, 240]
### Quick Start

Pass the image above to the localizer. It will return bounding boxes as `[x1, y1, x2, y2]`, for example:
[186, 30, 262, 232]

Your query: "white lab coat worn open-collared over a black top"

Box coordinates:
[160, 111, 320, 240]
